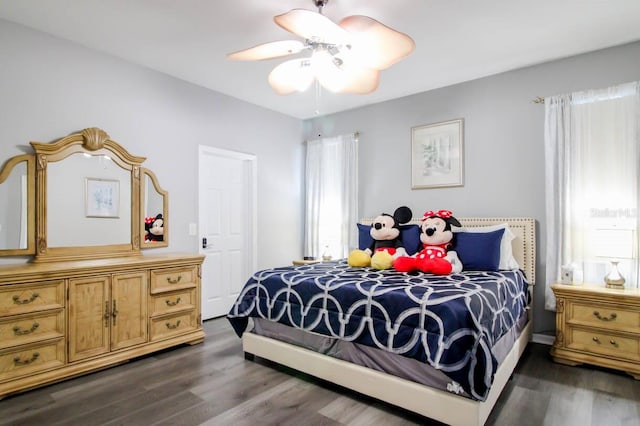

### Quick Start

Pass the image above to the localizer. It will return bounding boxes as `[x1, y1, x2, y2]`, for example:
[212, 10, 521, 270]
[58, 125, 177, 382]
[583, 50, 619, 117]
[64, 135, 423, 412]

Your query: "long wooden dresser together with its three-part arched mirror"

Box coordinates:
[0, 127, 205, 399]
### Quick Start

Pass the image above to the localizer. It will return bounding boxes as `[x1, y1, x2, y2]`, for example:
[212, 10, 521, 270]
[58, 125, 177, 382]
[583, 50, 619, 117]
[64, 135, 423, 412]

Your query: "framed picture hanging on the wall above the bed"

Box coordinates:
[411, 118, 464, 189]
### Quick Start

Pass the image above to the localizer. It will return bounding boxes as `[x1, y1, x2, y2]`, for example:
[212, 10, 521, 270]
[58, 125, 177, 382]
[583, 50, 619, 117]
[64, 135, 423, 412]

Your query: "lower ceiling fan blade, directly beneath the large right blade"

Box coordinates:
[313, 58, 380, 95]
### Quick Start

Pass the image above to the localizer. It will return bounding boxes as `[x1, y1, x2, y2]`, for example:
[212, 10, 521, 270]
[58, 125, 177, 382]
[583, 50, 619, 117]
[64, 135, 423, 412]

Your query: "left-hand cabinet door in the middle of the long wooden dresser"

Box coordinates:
[69, 276, 111, 362]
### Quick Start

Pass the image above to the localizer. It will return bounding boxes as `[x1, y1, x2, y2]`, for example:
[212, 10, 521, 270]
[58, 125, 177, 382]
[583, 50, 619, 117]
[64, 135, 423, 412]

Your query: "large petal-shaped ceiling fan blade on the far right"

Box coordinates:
[339, 15, 415, 70]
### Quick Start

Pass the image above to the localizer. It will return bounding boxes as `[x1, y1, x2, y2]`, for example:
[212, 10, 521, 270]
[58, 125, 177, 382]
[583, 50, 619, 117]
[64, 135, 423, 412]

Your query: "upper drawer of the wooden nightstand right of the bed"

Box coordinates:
[567, 302, 640, 331]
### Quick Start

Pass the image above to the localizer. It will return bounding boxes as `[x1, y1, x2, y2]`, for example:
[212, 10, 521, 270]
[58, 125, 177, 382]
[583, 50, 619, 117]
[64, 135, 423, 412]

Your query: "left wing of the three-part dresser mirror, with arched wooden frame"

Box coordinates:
[0, 154, 35, 256]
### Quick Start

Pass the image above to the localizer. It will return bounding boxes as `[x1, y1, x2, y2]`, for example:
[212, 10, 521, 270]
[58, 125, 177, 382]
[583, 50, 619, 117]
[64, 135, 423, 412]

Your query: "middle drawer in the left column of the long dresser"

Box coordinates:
[0, 309, 64, 349]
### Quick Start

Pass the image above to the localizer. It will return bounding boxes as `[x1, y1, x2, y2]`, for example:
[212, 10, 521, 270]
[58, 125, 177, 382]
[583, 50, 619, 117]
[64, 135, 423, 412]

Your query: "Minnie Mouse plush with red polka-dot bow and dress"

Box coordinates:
[393, 210, 462, 275]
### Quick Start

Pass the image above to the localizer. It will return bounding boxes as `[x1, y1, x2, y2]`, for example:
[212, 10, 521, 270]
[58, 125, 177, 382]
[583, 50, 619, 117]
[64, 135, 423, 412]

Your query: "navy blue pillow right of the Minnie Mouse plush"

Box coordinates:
[455, 229, 504, 271]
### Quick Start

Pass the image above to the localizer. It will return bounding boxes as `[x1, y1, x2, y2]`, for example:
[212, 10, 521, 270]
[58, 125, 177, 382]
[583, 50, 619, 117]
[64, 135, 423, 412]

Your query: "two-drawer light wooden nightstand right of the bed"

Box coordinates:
[551, 284, 640, 380]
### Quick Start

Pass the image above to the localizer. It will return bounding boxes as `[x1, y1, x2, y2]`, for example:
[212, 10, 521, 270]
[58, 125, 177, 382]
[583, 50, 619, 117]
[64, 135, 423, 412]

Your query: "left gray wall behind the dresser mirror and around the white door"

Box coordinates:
[0, 20, 304, 268]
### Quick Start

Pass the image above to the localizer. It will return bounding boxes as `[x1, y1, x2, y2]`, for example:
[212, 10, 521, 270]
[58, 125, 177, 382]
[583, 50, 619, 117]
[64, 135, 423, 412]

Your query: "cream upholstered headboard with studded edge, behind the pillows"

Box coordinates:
[360, 217, 536, 285]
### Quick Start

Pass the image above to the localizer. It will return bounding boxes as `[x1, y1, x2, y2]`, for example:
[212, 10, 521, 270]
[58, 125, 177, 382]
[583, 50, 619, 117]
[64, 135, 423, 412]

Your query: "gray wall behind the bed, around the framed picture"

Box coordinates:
[304, 43, 640, 333]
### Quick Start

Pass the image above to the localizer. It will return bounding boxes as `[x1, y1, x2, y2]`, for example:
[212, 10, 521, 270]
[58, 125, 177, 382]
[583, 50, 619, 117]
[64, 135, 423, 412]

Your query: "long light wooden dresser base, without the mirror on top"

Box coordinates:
[0, 254, 205, 398]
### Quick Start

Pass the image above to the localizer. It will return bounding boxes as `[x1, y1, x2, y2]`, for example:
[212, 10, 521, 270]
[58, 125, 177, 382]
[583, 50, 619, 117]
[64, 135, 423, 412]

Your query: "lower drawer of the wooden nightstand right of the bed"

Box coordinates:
[567, 327, 640, 361]
